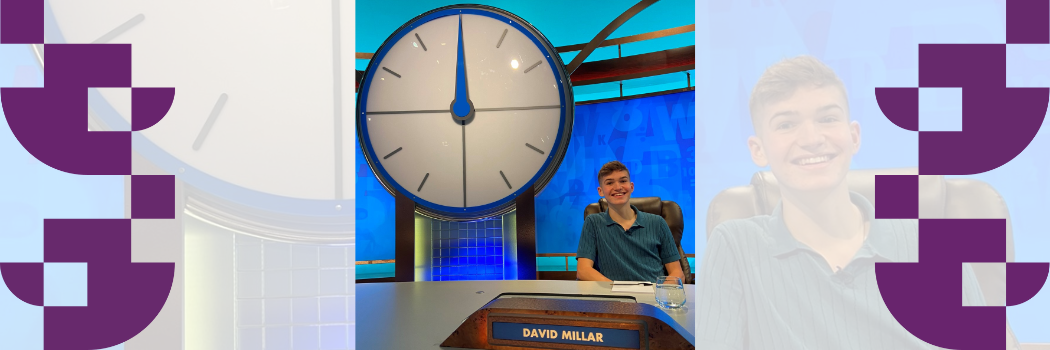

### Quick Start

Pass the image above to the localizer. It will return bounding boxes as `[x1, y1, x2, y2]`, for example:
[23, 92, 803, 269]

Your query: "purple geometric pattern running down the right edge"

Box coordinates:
[875, 0, 1050, 349]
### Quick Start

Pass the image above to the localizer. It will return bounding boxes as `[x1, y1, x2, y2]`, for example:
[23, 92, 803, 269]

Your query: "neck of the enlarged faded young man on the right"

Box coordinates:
[782, 183, 865, 241]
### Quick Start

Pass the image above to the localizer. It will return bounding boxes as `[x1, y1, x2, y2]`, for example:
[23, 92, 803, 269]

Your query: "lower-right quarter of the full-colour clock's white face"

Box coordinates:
[466, 109, 560, 206]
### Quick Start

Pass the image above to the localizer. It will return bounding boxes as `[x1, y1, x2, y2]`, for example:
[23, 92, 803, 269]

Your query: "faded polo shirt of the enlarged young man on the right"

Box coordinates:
[696, 193, 984, 350]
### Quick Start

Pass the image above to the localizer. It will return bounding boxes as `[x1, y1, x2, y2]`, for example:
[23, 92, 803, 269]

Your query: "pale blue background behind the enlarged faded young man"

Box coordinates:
[696, 0, 1050, 343]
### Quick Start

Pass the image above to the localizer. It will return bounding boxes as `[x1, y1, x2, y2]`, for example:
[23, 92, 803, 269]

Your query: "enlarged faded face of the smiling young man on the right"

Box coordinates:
[748, 85, 860, 191]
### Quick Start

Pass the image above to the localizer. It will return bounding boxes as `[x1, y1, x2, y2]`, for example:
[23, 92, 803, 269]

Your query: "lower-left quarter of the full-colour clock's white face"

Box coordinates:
[366, 114, 463, 207]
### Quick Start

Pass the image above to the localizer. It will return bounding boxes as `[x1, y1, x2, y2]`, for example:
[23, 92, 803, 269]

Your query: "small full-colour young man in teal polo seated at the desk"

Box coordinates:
[576, 161, 686, 282]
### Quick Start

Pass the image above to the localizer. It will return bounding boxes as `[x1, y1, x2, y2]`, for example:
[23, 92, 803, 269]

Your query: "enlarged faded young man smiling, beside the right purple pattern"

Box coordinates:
[696, 56, 1012, 350]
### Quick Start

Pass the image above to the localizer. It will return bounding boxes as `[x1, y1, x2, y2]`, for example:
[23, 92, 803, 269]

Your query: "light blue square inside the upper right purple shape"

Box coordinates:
[919, 87, 963, 131]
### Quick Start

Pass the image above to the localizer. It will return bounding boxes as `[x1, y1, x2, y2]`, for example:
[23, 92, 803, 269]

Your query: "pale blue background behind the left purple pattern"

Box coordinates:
[0, 45, 124, 350]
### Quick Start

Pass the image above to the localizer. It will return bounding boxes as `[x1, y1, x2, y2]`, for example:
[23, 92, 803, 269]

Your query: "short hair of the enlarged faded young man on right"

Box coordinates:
[748, 55, 849, 131]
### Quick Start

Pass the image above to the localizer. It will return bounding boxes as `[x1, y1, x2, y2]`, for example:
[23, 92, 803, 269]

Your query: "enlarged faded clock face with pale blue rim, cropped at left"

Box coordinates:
[45, 0, 355, 216]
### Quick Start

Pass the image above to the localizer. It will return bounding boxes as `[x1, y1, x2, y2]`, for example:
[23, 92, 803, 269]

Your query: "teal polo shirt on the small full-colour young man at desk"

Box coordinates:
[576, 205, 680, 282]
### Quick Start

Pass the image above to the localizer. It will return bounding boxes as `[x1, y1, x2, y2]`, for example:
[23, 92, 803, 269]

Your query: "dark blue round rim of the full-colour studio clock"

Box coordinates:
[355, 5, 571, 219]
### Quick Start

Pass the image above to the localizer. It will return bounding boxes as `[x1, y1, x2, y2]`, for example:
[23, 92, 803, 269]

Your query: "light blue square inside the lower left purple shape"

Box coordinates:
[44, 263, 87, 306]
